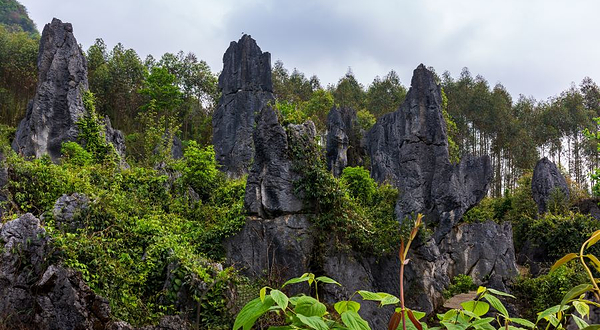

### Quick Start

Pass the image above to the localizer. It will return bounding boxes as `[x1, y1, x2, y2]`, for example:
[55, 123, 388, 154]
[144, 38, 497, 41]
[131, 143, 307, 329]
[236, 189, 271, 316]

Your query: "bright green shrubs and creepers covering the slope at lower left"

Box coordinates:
[3, 132, 245, 329]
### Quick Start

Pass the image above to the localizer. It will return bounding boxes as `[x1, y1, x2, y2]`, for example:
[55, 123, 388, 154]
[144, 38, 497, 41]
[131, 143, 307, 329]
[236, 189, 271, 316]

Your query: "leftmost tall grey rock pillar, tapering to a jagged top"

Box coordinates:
[12, 18, 88, 160]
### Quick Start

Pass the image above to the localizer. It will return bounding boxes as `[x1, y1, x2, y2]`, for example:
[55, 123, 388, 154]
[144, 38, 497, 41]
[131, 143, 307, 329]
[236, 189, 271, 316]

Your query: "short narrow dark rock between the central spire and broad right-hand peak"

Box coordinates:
[326, 107, 363, 177]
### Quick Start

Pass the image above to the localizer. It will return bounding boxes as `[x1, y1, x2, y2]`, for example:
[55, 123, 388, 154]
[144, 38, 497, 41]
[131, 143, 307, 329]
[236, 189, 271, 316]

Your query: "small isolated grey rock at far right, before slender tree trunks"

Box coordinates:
[531, 157, 569, 213]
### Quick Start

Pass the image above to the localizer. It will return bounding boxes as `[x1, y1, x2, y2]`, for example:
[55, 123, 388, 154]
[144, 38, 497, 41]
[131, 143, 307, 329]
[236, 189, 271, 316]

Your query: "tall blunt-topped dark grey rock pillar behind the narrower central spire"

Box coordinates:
[213, 35, 274, 177]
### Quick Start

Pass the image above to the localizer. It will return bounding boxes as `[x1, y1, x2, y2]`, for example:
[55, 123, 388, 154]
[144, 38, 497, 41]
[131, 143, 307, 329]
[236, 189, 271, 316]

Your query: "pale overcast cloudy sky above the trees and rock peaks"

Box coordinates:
[20, 0, 600, 100]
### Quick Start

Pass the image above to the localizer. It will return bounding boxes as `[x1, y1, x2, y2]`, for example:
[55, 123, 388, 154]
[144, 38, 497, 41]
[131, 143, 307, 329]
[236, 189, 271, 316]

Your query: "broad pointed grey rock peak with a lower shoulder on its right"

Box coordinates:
[366, 64, 492, 239]
